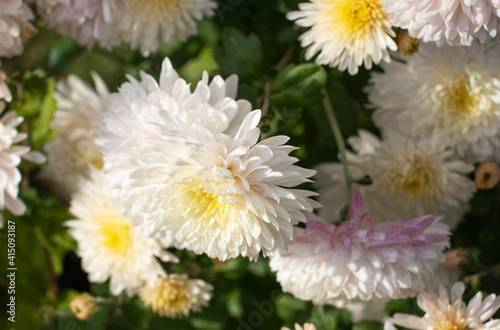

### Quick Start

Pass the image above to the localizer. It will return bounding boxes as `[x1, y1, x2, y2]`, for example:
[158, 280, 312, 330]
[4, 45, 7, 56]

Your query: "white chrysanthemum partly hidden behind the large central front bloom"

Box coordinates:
[96, 59, 252, 229]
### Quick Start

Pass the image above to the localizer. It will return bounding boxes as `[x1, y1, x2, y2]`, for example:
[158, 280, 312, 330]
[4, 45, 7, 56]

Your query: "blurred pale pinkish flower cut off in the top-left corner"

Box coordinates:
[0, 0, 36, 57]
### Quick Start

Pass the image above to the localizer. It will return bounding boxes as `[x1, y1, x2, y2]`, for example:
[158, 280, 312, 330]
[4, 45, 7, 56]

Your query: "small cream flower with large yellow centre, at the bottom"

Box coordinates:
[139, 274, 213, 318]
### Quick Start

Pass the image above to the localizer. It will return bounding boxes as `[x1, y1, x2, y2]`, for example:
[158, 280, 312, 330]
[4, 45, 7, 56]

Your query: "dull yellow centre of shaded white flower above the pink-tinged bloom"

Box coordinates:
[385, 155, 436, 196]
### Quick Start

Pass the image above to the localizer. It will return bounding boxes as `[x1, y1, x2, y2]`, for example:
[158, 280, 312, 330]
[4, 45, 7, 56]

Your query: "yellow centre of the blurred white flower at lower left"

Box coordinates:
[99, 214, 134, 254]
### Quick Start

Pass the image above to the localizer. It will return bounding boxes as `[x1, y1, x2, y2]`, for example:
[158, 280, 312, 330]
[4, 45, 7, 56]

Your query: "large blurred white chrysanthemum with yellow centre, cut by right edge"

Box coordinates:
[368, 44, 500, 162]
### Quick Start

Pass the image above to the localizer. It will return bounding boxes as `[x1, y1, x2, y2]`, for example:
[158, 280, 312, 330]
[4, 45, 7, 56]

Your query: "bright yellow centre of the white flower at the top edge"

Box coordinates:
[329, 0, 386, 39]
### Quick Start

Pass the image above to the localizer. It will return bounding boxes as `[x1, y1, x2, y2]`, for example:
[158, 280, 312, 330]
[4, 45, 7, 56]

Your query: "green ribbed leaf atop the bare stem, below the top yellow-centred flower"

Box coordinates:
[271, 63, 326, 108]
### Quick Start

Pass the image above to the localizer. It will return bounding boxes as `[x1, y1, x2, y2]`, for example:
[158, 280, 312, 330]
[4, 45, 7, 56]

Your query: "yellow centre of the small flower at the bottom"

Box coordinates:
[145, 274, 192, 317]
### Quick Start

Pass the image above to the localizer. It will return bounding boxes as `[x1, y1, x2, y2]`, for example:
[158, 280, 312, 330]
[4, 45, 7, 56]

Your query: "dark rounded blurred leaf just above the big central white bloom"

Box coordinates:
[215, 28, 262, 80]
